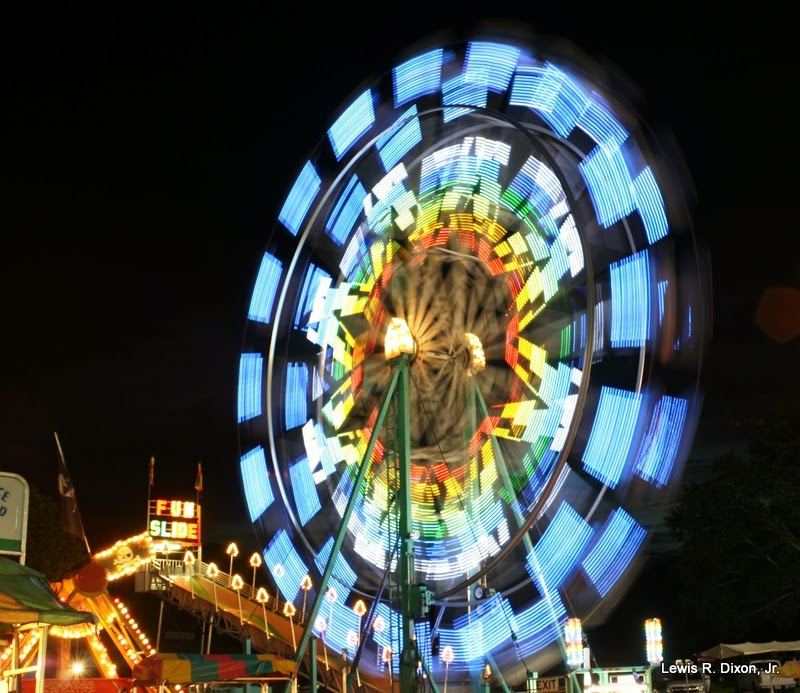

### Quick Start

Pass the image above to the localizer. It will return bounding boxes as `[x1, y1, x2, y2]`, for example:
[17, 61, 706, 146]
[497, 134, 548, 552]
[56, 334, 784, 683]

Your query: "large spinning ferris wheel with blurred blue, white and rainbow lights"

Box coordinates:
[238, 29, 707, 683]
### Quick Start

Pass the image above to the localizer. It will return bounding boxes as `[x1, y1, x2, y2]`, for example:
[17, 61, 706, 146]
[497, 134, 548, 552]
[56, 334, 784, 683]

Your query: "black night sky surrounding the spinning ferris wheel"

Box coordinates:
[0, 2, 800, 664]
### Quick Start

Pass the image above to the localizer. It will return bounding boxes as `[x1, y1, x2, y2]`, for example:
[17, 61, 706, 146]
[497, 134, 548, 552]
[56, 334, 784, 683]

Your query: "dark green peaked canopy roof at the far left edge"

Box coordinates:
[0, 556, 97, 629]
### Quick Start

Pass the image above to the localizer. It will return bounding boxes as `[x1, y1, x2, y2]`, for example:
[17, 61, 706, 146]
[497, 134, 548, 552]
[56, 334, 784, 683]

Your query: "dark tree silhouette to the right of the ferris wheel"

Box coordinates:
[668, 413, 800, 642]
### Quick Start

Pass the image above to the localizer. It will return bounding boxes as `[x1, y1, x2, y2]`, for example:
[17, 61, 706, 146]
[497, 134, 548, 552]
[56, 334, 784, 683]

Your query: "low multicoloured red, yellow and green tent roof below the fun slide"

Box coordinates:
[133, 652, 294, 685]
